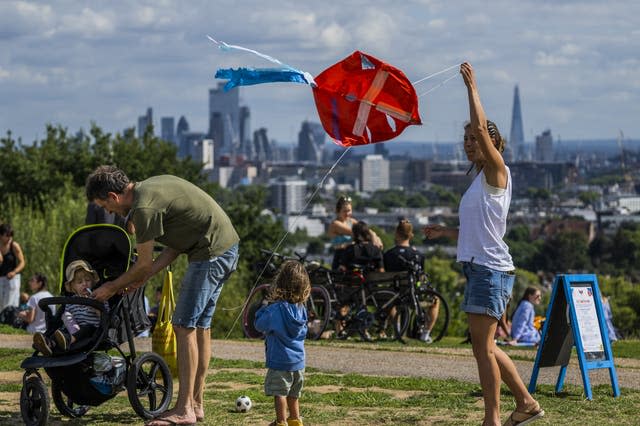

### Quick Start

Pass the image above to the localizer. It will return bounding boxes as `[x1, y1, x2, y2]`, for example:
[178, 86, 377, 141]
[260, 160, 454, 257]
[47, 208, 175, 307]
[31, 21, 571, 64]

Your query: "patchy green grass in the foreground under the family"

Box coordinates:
[0, 339, 640, 425]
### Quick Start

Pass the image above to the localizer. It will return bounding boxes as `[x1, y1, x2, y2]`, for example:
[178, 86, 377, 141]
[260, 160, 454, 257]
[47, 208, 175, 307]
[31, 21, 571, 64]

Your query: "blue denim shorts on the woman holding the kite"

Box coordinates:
[460, 262, 516, 319]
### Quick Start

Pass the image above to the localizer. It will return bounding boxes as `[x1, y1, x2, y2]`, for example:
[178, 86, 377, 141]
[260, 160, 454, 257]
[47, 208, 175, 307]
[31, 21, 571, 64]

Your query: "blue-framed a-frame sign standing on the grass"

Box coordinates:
[529, 274, 620, 399]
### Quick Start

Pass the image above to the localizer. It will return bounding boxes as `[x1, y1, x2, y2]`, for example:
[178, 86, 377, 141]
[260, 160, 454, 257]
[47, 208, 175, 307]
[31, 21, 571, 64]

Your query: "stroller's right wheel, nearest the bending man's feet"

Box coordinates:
[127, 352, 173, 419]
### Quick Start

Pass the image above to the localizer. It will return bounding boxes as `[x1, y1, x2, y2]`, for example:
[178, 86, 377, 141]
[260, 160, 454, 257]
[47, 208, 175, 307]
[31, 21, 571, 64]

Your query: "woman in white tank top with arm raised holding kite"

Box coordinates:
[424, 62, 544, 426]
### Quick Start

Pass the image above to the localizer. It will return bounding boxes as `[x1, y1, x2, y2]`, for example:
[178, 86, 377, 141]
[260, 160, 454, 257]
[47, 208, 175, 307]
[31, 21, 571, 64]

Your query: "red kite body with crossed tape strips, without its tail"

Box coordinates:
[313, 51, 422, 147]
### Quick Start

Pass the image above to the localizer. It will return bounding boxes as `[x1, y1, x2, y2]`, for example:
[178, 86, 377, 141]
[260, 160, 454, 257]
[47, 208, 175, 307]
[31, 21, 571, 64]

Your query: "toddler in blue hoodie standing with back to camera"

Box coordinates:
[255, 260, 311, 426]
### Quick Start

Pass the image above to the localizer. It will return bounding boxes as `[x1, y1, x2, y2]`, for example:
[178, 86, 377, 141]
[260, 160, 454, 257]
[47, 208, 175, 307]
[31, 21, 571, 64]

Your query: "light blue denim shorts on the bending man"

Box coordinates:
[171, 244, 238, 328]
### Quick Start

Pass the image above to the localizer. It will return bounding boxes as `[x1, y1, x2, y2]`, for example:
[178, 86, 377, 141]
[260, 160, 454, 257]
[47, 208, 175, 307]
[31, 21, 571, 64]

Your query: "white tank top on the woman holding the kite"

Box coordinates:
[458, 167, 514, 271]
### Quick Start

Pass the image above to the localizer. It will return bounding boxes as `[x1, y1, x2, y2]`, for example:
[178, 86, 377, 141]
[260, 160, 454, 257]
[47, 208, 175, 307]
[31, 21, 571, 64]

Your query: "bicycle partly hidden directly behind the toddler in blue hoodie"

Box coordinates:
[242, 250, 331, 340]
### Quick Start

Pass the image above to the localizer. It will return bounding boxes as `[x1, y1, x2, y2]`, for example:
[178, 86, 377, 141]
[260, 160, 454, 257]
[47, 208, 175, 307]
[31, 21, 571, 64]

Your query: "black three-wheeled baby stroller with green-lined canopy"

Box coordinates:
[20, 225, 173, 425]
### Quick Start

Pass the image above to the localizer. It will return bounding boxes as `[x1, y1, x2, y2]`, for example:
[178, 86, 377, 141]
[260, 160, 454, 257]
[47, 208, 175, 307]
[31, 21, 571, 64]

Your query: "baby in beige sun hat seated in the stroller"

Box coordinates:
[33, 260, 109, 356]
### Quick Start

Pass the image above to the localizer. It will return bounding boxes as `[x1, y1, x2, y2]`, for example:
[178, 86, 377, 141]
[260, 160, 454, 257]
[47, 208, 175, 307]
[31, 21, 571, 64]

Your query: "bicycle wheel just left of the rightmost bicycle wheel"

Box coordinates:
[361, 290, 409, 340]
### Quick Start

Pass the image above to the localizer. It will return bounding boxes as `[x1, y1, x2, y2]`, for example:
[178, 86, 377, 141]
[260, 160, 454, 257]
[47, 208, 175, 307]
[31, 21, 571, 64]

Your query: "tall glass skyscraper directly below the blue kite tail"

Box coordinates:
[208, 83, 240, 155]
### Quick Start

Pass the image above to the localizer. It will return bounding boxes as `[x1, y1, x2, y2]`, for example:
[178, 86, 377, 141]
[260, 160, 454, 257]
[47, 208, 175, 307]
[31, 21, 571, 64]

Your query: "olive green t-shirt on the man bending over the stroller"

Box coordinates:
[130, 175, 240, 262]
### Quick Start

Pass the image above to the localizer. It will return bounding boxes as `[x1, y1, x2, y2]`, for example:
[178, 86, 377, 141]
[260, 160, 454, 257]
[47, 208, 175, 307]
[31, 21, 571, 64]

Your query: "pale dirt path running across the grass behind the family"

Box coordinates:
[0, 335, 640, 389]
